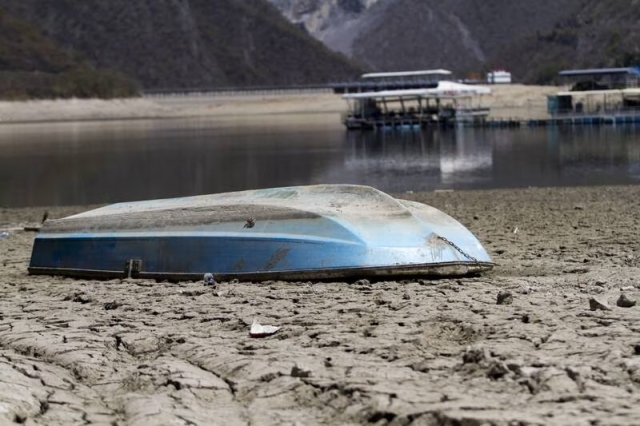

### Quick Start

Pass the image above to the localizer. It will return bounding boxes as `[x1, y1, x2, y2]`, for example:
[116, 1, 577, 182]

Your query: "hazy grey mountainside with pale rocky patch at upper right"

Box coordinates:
[270, 0, 640, 82]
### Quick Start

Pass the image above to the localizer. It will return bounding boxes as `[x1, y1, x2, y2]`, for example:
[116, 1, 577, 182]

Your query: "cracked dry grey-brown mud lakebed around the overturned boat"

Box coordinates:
[0, 187, 640, 426]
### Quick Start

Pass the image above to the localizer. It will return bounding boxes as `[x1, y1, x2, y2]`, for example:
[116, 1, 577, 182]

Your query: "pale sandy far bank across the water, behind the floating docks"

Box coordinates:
[0, 85, 557, 123]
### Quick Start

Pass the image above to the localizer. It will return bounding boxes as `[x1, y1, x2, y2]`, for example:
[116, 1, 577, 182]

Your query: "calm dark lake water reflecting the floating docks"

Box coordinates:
[0, 115, 640, 207]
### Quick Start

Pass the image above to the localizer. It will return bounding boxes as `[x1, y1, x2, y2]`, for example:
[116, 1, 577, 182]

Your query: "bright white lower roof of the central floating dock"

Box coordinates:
[342, 81, 491, 99]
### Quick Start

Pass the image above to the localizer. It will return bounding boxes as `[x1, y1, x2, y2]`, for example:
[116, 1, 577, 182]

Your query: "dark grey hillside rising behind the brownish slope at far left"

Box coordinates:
[0, 0, 361, 89]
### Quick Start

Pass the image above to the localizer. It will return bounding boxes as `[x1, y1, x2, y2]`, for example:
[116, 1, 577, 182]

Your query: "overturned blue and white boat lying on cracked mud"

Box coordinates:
[29, 185, 493, 280]
